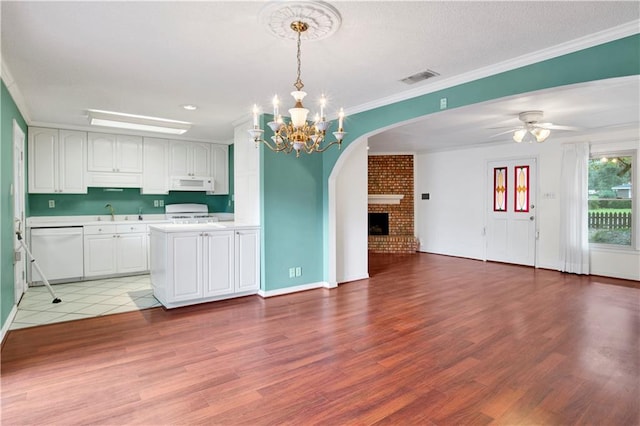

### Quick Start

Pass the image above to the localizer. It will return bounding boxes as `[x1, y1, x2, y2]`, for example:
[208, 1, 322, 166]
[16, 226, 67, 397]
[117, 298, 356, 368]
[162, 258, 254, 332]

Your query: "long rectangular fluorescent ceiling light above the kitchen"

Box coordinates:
[88, 109, 191, 135]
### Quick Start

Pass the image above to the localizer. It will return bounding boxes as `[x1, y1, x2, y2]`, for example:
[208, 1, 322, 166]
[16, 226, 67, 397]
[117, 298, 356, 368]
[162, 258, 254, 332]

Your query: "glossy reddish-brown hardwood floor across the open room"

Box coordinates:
[1, 254, 640, 425]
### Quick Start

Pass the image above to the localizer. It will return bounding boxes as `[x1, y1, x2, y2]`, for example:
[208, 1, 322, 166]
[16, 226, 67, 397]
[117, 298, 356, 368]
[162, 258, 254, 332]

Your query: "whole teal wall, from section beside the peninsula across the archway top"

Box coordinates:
[261, 35, 640, 290]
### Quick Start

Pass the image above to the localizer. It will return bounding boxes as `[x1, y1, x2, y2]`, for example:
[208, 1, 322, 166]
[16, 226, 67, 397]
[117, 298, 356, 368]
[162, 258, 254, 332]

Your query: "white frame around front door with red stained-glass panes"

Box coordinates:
[482, 153, 540, 268]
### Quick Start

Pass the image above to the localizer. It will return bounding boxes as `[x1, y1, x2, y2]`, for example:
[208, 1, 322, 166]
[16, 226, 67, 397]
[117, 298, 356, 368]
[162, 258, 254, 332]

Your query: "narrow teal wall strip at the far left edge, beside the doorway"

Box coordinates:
[0, 81, 27, 326]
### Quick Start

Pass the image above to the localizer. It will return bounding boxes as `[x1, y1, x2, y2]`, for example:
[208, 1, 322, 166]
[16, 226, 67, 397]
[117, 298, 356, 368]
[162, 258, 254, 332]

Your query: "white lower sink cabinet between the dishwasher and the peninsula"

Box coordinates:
[84, 224, 148, 277]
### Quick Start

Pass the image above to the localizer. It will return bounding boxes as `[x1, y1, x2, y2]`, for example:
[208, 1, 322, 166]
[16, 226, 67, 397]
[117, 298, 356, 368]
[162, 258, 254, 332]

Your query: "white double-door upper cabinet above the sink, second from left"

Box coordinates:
[87, 133, 142, 173]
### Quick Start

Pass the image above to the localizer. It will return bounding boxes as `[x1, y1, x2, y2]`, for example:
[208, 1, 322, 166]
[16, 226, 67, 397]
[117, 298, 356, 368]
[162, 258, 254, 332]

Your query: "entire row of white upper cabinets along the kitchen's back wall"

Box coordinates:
[28, 127, 229, 195]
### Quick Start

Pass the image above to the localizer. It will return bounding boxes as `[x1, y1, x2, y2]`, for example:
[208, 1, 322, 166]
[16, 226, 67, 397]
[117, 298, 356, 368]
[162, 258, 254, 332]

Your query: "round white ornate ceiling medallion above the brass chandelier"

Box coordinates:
[259, 1, 342, 40]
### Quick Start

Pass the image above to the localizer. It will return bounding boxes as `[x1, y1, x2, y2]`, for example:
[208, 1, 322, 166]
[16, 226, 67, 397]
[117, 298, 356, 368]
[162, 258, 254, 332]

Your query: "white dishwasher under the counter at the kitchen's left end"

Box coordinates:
[30, 226, 84, 285]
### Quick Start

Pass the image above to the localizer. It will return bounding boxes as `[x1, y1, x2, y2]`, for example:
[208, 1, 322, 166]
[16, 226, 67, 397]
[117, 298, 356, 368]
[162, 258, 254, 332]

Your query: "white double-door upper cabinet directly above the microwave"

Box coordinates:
[169, 141, 211, 177]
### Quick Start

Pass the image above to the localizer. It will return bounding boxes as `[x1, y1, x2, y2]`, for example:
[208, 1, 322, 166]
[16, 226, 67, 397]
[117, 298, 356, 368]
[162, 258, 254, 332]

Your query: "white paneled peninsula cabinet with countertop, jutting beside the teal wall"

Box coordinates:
[149, 222, 260, 308]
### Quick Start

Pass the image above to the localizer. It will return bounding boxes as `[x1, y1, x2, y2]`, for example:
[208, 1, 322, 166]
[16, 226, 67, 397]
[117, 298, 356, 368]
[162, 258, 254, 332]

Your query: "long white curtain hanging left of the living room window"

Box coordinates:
[560, 142, 589, 274]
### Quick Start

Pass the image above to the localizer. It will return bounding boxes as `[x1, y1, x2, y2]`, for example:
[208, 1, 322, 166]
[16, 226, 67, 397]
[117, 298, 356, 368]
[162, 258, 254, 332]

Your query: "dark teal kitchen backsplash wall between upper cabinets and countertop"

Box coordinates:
[27, 145, 234, 217]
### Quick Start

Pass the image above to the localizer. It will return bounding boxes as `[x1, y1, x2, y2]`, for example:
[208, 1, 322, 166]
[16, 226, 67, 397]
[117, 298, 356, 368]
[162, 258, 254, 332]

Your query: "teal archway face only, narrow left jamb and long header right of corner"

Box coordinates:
[322, 34, 640, 281]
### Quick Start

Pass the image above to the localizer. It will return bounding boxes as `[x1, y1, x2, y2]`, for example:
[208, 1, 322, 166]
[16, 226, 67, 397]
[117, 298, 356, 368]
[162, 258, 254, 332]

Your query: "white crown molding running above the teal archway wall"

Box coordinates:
[345, 19, 640, 116]
